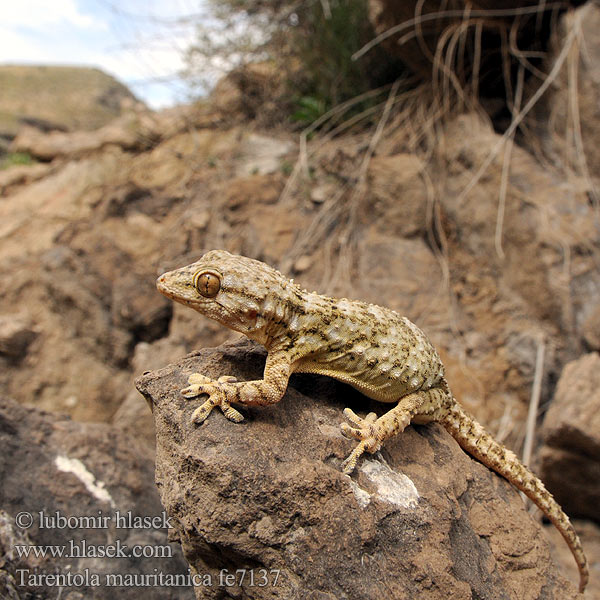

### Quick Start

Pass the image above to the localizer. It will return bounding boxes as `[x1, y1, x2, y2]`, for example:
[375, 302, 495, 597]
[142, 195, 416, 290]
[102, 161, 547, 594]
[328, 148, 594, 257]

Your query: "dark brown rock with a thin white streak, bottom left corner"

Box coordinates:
[0, 399, 193, 599]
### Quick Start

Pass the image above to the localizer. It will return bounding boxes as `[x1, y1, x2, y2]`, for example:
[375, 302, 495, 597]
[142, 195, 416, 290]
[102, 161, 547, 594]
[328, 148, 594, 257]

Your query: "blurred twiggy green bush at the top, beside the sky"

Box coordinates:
[196, 0, 402, 126]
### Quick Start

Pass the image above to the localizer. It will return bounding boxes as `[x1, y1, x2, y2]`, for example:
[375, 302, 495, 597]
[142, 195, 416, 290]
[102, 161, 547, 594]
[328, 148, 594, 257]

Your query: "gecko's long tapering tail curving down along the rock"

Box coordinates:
[441, 401, 589, 592]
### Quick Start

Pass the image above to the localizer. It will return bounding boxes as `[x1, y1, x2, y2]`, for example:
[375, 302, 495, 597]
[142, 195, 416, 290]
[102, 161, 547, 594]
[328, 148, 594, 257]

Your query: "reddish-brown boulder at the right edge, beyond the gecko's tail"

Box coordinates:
[539, 352, 600, 519]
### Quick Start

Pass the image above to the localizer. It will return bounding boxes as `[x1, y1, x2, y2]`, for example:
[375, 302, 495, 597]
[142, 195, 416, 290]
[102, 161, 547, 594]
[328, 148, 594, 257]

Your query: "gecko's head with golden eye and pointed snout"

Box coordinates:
[156, 250, 289, 335]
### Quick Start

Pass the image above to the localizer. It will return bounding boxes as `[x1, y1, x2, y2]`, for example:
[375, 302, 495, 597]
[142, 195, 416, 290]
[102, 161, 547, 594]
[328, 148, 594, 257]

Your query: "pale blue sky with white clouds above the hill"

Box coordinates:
[0, 0, 208, 108]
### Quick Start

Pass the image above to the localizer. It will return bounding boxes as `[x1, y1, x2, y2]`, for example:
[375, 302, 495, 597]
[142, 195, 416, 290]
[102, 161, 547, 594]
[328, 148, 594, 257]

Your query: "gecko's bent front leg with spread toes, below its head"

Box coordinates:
[181, 354, 290, 423]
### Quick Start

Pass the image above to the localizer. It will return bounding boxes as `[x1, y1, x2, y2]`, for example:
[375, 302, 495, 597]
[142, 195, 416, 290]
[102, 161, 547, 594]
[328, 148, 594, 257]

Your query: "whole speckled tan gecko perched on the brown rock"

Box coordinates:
[156, 250, 589, 592]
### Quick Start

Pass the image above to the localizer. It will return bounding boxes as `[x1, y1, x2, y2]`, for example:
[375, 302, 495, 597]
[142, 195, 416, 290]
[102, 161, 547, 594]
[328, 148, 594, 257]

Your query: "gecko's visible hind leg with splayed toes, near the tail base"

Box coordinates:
[341, 392, 428, 475]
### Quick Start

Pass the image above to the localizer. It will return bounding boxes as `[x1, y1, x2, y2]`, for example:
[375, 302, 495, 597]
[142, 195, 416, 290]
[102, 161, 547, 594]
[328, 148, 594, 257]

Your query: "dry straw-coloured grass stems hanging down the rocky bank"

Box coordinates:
[274, 2, 600, 451]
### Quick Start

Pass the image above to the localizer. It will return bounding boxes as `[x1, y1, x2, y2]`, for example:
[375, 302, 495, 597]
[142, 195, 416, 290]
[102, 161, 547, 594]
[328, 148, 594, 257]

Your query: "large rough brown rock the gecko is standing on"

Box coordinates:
[136, 341, 577, 600]
